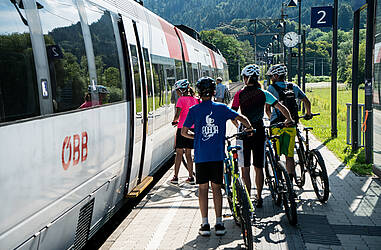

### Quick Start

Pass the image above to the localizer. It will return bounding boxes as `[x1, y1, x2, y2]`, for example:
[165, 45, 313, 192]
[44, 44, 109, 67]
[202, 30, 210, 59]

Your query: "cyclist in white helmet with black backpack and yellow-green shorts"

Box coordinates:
[266, 64, 312, 186]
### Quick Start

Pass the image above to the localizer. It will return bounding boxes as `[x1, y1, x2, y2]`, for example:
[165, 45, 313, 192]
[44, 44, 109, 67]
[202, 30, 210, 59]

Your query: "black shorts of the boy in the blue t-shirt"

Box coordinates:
[196, 161, 224, 184]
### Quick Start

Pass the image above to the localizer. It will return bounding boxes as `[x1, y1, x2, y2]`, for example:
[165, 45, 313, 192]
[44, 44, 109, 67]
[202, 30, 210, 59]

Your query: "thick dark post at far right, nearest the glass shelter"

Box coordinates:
[365, 0, 375, 164]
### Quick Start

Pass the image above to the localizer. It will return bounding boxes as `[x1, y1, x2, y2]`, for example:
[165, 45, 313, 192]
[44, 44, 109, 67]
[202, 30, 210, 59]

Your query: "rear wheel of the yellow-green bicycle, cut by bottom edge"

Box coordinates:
[236, 180, 253, 249]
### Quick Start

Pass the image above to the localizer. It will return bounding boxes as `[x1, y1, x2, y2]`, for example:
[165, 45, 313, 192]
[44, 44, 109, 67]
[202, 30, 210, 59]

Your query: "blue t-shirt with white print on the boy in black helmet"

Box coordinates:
[184, 101, 238, 163]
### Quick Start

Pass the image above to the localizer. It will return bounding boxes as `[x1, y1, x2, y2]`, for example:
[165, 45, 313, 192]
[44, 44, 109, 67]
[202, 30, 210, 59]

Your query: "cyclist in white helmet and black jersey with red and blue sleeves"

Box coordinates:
[232, 64, 293, 208]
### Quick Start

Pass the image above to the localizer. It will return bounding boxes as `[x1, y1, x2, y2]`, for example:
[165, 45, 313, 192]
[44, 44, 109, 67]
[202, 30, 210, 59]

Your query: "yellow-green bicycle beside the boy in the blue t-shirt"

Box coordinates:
[224, 131, 255, 249]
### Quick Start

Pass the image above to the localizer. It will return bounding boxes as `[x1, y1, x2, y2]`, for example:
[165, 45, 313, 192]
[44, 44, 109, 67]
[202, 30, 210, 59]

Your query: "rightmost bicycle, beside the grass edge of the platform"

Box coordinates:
[295, 113, 329, 203]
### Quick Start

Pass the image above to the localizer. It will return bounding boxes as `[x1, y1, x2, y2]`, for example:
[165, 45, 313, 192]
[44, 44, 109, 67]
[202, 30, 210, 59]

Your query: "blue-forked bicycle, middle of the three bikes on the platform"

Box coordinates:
[265, 123, 298, 225]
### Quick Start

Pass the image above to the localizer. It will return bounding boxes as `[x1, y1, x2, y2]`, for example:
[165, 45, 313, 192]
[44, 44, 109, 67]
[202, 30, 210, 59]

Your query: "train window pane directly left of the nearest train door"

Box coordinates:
[85, 2, 123, 104]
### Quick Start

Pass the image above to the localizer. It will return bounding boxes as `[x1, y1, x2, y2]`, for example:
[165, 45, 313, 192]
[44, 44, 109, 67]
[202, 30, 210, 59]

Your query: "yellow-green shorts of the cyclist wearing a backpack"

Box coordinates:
[271, 127, 296, 157]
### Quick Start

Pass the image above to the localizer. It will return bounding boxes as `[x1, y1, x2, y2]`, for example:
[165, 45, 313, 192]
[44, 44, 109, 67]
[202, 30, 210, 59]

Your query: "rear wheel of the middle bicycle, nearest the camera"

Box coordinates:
[278, 161, 298, 225]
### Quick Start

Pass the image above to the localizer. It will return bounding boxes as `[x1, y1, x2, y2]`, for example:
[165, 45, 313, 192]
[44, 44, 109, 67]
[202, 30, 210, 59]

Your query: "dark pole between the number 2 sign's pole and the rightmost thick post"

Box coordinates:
[351, 10, 360, 151]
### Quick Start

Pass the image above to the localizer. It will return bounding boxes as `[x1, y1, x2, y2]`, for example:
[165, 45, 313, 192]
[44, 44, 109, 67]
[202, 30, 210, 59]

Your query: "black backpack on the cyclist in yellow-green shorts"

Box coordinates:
[272, 82, 299, 123]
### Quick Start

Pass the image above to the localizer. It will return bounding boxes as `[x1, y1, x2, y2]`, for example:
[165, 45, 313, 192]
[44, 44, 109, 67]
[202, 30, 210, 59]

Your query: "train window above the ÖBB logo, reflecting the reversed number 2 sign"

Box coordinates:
[39, 0, 90, 112]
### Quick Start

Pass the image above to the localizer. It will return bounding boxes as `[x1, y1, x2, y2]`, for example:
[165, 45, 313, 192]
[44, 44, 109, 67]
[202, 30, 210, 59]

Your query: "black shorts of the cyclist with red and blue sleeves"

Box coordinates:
[238, 126, 265, 168]
